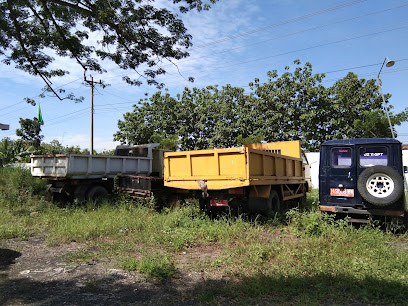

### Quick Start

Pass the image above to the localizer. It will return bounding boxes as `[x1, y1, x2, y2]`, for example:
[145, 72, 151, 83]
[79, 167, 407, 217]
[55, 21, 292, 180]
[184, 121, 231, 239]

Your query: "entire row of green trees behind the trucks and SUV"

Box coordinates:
[114, 60, 408, 151]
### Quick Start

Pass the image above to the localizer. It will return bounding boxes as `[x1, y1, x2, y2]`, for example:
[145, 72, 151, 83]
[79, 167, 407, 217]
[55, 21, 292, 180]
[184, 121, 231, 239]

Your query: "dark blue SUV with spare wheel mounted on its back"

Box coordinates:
[319, 138, 407, 221]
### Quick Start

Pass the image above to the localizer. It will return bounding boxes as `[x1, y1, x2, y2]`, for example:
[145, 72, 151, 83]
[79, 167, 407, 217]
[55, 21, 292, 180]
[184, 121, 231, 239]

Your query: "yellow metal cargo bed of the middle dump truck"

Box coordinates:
[164, 141, 305, 190]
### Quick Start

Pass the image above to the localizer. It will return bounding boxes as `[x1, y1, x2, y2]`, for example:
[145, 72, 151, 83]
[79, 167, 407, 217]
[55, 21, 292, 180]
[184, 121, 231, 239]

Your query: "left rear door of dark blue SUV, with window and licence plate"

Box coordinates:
[325, 146, 358, 206]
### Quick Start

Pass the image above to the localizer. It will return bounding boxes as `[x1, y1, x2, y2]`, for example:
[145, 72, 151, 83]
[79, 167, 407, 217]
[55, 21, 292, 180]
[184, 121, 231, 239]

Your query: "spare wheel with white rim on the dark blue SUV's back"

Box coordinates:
[357, 166, 404, 207]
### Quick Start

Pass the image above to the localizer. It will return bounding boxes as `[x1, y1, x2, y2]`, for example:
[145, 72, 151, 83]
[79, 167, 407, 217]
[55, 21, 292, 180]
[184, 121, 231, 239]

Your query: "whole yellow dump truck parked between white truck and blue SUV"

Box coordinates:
[164, 141, 308, 215]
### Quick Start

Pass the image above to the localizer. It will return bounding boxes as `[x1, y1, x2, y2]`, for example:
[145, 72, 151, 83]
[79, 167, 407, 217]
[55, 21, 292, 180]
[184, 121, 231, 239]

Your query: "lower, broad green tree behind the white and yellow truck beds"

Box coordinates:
[114, 85, 252, 150]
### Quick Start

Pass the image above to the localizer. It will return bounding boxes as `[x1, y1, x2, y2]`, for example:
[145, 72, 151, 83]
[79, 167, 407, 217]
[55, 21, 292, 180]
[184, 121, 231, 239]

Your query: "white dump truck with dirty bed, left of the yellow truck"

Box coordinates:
[31, 143, 163, 202]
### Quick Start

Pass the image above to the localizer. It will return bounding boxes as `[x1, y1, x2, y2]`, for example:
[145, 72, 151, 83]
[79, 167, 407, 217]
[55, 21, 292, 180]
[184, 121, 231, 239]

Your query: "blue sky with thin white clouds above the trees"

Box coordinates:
[0, 0, 408, 152]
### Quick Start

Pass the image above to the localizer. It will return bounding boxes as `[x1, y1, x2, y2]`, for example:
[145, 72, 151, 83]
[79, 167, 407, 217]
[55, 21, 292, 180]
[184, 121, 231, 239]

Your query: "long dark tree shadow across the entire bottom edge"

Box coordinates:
[0, 275, 408, 305]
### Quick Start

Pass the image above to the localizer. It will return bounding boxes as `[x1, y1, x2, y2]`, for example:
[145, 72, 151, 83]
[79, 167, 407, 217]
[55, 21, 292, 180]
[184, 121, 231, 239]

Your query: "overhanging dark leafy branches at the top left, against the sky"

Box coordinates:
[0, 0, 217, 96]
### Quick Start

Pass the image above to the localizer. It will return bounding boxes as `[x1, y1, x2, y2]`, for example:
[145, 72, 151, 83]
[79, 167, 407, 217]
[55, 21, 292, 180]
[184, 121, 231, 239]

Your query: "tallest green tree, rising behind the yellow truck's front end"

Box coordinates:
[250, 60, 330, 150]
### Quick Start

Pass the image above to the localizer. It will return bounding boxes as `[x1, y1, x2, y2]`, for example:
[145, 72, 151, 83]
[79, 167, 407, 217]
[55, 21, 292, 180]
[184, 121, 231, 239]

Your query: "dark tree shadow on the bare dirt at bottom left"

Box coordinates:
[0, 276, 182, 305]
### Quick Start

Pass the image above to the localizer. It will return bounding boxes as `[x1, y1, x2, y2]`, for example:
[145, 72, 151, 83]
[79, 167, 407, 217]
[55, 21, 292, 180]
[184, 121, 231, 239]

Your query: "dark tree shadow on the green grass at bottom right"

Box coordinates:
[194, 275, 408, 305]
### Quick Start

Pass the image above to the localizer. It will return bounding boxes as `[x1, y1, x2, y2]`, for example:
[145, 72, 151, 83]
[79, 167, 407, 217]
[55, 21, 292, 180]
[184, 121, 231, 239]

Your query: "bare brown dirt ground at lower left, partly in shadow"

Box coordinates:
[0, 238, 226, 305]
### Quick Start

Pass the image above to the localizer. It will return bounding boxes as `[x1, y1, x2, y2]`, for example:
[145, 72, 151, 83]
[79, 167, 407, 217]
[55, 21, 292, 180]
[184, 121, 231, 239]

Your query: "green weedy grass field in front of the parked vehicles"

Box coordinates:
[0, 169, 408, 304]
